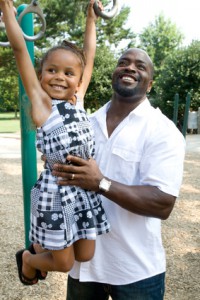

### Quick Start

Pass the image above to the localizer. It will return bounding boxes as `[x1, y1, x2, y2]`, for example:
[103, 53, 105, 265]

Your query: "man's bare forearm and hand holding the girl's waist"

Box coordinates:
[52, 155, 176, 220]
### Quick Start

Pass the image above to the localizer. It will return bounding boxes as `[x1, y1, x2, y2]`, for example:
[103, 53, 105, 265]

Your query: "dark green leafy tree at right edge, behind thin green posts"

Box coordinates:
[155, 41, 200, 118]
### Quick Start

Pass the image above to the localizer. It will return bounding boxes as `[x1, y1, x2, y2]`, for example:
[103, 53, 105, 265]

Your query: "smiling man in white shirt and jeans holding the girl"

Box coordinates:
[53, 48, 185, 300]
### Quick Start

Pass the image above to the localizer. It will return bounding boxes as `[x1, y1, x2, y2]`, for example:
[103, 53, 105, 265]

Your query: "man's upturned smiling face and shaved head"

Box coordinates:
[112, 48, 153, 98]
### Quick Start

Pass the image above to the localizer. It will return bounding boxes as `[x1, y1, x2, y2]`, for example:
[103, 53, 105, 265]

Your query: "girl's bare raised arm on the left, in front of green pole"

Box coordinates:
[0, 0, 51, 126]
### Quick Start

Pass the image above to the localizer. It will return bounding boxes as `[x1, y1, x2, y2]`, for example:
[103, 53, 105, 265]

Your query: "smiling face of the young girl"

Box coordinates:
[39, 49, 82, 100]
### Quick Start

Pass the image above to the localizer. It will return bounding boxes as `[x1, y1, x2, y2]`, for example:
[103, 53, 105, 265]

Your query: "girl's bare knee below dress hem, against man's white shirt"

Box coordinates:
[74, 239, 95, 262]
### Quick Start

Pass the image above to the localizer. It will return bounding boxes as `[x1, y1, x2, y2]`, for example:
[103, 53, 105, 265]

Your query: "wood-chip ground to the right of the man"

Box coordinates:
[163, 153, 200, 300]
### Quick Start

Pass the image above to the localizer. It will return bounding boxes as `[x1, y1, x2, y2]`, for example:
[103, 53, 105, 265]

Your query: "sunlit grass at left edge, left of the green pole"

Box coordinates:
[0, 112, 20, 133]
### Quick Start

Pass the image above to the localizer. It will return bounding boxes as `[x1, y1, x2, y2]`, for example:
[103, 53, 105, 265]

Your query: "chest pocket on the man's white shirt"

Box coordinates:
[112, 147, 142, 185]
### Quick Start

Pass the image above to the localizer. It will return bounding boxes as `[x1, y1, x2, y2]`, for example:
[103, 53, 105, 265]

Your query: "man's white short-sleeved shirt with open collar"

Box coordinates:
[70, 99, 185, 285]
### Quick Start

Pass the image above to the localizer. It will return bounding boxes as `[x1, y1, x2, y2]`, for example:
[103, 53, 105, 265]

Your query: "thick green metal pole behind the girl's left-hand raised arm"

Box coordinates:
[17, 4, 37, 247]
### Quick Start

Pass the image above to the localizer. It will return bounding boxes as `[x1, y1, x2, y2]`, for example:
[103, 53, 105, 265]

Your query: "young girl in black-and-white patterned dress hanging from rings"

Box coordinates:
[0, 0, 109, 285]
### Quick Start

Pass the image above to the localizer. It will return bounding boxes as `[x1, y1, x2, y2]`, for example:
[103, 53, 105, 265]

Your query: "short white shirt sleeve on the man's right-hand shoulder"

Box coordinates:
[140, 117, 185, 197]
